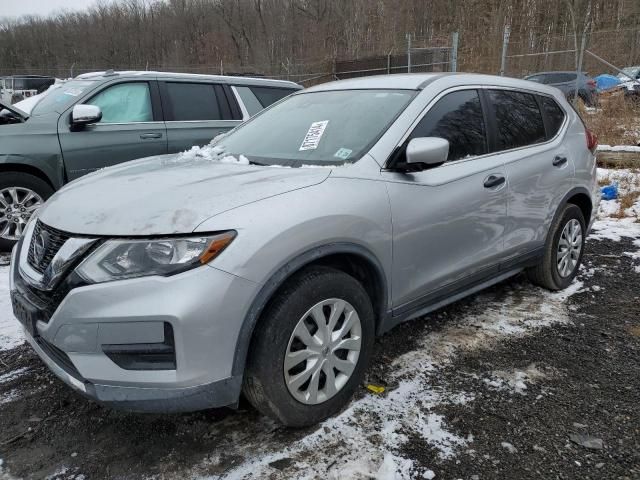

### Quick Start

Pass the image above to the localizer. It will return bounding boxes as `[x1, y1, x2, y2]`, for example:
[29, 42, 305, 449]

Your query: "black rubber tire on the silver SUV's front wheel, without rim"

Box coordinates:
[243, 266, 375, 427]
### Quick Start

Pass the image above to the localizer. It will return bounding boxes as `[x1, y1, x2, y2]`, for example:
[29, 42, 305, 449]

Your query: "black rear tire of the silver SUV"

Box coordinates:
[527, 203, 586, 291]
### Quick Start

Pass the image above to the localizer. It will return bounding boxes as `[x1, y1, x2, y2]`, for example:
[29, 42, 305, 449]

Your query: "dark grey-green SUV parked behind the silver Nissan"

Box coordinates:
[0, 71, 302, 251]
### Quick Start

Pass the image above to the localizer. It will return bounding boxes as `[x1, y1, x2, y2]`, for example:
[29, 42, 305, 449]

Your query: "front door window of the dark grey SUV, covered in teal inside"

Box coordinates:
[87, 82, 153, 123]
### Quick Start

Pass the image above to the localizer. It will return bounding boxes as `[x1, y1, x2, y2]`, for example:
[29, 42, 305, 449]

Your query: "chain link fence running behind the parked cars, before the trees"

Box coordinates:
[0, 27, 640, 86]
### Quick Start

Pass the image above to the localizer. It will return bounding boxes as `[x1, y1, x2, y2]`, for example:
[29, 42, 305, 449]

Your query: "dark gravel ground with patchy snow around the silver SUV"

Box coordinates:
[0, 230, 640, 480]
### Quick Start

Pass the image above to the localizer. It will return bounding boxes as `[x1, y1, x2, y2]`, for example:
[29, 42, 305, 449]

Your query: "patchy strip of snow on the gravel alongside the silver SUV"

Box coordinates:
[176, 282, 581, 480]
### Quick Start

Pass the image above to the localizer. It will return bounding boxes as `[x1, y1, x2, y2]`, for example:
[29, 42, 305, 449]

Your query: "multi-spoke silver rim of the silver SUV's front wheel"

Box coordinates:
[284, 298, 362, 405]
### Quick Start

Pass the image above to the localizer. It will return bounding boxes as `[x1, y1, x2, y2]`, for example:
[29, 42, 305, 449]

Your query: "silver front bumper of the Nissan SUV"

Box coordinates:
[10, 238, 258, 412]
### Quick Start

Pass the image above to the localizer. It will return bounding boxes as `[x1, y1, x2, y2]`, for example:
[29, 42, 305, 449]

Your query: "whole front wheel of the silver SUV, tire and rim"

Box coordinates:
[243, 267, 375, 427]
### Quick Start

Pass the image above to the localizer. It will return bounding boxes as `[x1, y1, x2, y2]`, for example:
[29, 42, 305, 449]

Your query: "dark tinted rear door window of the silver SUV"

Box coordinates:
[489, 90, 546, 151]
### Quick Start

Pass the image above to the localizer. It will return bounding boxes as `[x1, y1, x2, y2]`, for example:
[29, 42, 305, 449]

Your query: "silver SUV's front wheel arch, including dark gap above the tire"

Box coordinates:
[232, 242, 388, 375]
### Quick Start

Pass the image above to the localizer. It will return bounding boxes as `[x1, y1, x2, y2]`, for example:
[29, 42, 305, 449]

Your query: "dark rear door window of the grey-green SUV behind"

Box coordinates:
[164, 82, 222, 122]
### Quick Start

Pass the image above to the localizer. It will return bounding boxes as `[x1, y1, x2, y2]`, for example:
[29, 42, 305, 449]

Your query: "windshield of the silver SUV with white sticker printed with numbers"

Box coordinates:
[217, 90, 416, 167]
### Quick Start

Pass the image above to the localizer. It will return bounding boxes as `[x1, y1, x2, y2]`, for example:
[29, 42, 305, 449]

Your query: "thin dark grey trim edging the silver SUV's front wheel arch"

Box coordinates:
[231, 242, 390, 376]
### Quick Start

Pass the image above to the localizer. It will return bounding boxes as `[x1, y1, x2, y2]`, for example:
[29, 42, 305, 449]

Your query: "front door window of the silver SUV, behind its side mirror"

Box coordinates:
[407, 90, 488, 161]
